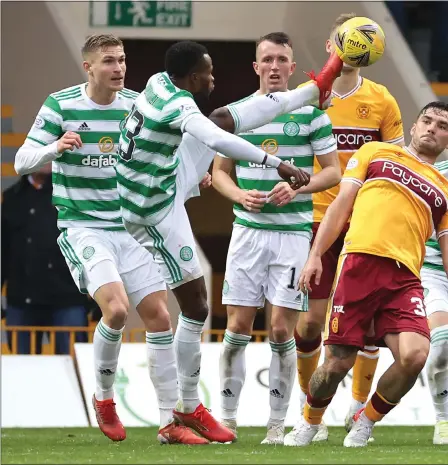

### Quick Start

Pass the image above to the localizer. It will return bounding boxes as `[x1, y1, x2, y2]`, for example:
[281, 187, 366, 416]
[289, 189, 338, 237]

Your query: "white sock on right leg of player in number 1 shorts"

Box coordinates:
[269, 338, 297, 422]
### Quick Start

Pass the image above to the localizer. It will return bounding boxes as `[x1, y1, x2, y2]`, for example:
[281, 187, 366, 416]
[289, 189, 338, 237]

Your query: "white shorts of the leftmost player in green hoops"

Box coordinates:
[58, 228, 166, 308]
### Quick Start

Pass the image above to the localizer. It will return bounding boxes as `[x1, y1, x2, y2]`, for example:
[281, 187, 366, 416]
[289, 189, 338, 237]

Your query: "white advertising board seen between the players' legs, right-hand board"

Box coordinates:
[75, 343, 435, 426]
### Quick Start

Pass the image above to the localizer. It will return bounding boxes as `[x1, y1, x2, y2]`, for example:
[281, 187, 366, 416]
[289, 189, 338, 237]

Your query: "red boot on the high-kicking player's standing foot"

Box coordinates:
[173, 404, 235, 442]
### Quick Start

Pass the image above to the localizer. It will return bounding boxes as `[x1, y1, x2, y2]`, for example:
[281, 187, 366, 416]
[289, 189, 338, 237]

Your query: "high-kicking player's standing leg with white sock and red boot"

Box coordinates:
[173, 277, 235, 442]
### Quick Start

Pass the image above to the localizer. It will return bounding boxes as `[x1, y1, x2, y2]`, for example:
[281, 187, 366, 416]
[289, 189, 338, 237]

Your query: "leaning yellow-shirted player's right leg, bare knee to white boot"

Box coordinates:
[344, 332, 429, 447]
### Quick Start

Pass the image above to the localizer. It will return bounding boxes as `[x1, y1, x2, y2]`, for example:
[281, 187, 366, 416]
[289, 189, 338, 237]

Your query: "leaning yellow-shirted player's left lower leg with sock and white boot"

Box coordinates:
[284, 345, 358, 446]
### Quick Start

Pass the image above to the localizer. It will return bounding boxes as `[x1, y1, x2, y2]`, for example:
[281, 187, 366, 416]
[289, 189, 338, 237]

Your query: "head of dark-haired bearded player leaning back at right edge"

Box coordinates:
[411, 101, 448, 157]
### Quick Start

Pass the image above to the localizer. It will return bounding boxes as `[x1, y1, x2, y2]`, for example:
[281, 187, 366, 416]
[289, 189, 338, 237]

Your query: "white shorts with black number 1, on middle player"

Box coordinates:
[222, 224, 310, 311]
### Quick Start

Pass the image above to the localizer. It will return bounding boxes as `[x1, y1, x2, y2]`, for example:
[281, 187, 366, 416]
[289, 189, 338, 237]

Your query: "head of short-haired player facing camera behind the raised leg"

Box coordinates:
[253, 32, 296, 92]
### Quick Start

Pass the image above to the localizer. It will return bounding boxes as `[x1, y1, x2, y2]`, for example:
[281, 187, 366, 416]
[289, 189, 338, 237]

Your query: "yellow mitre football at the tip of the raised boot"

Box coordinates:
[334, 16, 386, 68]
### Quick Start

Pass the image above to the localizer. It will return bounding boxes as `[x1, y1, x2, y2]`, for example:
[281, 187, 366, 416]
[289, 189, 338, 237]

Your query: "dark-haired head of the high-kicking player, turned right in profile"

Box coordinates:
[165, 40, 214, 97]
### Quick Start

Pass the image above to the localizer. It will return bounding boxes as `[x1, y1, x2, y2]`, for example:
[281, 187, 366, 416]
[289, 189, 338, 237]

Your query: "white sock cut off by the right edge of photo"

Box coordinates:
[426, 325, 448, 421]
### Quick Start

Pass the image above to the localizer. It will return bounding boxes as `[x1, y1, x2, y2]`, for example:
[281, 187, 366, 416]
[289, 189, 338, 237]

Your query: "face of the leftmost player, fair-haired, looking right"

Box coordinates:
[83, 45, 126, 92]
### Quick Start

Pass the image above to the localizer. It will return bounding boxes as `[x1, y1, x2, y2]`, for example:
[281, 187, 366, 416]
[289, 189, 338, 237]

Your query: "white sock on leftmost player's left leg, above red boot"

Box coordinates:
[93, 318, 124, 400]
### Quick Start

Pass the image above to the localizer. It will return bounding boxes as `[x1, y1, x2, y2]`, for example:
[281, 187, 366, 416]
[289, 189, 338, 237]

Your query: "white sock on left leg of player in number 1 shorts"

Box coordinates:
[219, 329, 251, 420]
